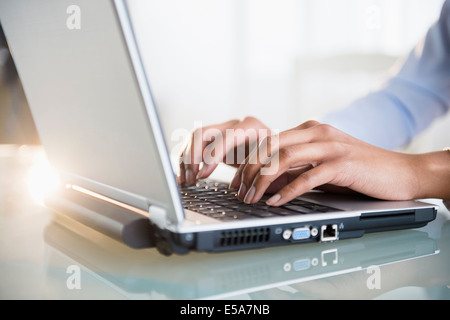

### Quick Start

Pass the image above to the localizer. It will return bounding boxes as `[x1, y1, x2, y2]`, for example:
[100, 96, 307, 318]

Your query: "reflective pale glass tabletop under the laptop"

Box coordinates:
[0, 146, 450, 300]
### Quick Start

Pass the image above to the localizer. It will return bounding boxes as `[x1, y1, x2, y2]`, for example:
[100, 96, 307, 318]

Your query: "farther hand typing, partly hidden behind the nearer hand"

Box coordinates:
[177, 117, 271, 185]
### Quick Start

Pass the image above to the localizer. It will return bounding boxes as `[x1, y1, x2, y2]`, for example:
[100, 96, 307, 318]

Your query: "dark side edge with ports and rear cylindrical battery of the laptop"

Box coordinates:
[45, 189, 436, 256]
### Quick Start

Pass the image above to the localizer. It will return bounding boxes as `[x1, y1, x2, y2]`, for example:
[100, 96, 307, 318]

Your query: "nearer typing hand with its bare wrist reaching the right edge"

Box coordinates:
[230, 121, 450, 206]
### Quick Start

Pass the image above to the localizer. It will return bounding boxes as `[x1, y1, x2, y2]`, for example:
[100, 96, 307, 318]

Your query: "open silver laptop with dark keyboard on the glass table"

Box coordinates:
[0, 0, 437, 254]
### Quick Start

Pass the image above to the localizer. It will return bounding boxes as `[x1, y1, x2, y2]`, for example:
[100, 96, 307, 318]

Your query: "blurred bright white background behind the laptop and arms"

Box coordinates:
[0, 0, 450, 153]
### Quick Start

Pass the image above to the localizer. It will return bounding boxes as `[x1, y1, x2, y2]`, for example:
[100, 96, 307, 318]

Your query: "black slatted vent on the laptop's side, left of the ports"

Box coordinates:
[220, 228, 270, 247]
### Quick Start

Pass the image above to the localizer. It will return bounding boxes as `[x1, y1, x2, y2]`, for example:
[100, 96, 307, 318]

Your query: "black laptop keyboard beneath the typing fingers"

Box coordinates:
[180, 180, 338, 220]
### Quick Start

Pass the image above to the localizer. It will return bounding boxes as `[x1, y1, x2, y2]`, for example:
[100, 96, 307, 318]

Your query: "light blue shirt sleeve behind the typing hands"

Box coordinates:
[321, 0, 450, 149]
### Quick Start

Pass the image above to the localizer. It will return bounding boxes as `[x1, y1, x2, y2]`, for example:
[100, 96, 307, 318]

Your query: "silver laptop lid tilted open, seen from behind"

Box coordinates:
[0, 0, 184, 224]
